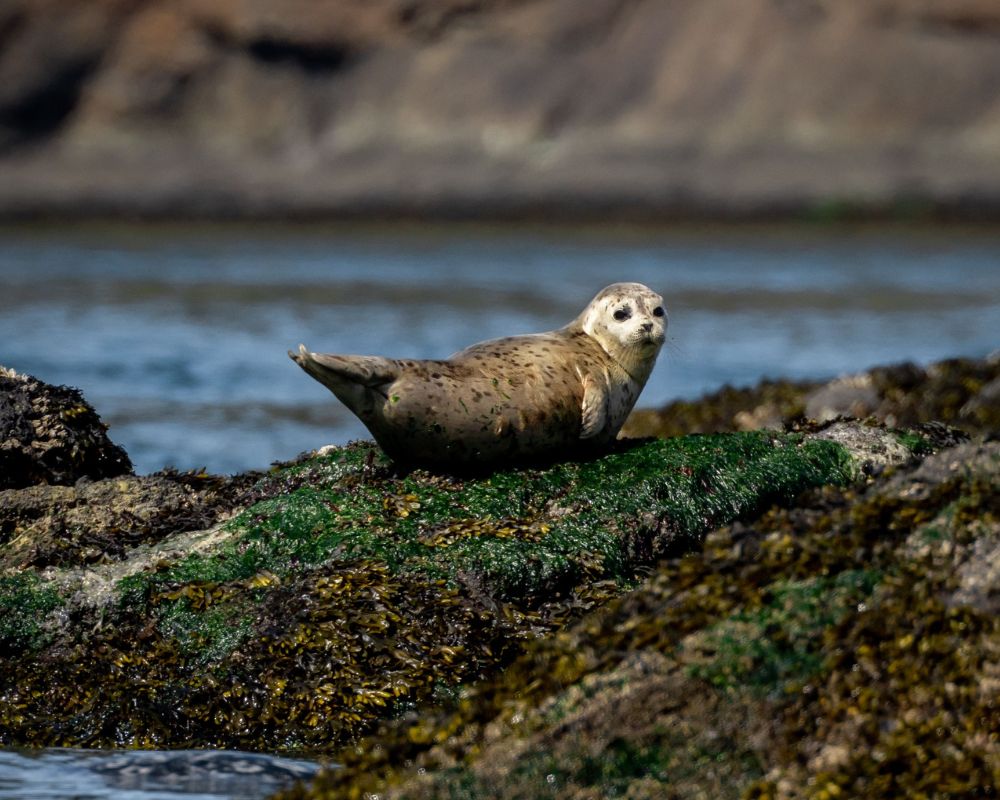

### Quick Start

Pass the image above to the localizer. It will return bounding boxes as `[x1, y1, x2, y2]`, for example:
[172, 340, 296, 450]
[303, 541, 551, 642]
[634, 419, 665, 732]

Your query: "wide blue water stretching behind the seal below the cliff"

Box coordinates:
[0, 225, 1000, 472]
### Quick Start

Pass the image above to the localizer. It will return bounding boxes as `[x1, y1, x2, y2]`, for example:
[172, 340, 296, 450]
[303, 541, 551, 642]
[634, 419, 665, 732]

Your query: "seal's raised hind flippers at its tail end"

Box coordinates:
[288, 344, 399, 419]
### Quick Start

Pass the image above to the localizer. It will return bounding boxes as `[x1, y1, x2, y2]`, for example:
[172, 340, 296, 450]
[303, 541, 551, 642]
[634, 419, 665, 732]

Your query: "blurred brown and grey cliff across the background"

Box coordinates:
[0, 0, 1000, 218]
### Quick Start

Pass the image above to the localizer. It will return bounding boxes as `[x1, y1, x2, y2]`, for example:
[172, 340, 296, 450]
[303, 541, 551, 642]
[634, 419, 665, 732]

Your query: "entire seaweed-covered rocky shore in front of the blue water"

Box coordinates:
[0, 359, 1000, 798]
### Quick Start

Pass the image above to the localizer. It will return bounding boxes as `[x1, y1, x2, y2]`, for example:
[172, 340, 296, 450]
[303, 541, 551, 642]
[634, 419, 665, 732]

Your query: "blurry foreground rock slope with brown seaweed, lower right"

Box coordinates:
[281, 441, 1000, 800]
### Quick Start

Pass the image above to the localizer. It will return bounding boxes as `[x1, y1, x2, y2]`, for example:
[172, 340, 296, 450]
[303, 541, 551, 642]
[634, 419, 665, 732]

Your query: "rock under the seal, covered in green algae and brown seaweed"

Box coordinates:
[0, 424, 895, 756]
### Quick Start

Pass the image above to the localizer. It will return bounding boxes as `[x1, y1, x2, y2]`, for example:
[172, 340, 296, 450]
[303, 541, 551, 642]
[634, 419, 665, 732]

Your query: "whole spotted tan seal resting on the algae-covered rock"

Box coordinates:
[288, 283, 667, 470]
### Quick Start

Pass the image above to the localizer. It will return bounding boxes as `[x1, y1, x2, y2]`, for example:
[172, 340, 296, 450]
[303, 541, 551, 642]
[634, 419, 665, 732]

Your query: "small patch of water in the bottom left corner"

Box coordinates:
[0, 749, 319, 800]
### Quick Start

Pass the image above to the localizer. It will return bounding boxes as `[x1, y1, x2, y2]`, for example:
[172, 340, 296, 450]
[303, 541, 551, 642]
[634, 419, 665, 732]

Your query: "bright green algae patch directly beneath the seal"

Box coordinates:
[154, 432, 851, 608]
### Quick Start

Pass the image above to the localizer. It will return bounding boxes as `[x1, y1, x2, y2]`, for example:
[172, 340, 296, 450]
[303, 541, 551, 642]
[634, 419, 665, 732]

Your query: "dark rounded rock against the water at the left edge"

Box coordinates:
[0, 367, 132, 489]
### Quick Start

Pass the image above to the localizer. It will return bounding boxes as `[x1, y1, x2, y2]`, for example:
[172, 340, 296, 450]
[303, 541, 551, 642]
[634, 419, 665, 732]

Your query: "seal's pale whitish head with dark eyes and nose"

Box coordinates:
[579, 283, 667, 383]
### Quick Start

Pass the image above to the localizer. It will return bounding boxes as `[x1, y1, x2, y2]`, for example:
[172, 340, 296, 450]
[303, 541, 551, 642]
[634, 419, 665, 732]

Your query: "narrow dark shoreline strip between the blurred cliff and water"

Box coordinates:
[0, 194, 1000, 231]
